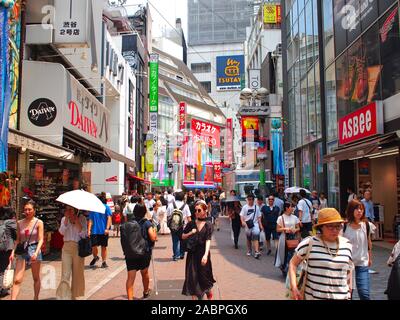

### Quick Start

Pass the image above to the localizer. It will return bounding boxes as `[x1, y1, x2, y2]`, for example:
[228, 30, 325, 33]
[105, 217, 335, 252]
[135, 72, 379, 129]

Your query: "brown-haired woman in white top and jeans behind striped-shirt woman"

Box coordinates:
[343, 200, 372, 300]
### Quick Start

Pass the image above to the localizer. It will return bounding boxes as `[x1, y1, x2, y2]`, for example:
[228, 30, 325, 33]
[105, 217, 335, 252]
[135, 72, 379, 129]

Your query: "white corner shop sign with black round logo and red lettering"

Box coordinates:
[21, 61, 110, 147]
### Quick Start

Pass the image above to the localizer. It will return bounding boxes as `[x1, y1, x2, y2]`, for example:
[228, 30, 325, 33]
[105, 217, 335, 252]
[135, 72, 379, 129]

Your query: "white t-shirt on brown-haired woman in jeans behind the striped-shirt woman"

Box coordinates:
[343, 223, 372, 267]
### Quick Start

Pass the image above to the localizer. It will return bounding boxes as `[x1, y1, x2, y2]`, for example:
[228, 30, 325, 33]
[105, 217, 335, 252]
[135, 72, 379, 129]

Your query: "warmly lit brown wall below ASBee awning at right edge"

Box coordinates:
[371, 156, 398, 232]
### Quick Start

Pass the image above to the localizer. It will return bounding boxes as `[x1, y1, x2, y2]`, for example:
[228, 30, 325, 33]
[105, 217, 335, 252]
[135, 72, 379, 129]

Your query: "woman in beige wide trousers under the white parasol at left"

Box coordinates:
[56, 206, 87, 300]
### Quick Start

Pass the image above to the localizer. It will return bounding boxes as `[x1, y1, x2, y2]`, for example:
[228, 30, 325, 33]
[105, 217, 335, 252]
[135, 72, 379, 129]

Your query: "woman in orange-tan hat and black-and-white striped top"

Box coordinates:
[289, 208, 354, 300]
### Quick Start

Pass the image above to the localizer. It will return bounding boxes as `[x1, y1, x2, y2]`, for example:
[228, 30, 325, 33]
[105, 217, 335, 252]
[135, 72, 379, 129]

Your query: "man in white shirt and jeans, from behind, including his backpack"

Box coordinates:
[167, 191, 191, 261]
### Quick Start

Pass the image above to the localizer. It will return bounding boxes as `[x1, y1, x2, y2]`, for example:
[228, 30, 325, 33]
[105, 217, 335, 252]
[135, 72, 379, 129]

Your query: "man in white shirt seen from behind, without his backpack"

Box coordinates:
[167, 191, 191, 261]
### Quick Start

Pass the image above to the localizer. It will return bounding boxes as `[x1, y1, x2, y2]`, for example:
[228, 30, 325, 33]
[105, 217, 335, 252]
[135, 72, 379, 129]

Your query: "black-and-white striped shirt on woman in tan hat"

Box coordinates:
[296, 237, 354, 300]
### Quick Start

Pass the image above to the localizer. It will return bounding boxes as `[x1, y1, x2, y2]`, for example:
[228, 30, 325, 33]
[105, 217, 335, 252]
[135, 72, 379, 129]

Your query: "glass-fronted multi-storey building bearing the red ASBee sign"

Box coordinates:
[282, 0, 400, 234]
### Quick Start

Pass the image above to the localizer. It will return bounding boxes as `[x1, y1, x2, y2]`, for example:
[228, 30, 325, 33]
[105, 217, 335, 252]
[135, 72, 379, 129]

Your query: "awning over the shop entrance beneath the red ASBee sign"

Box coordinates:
[324, 132, 400, 163]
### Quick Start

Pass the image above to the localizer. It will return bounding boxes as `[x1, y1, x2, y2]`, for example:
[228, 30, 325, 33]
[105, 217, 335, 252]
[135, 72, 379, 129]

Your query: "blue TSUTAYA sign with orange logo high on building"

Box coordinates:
[217, 55, 244, 91]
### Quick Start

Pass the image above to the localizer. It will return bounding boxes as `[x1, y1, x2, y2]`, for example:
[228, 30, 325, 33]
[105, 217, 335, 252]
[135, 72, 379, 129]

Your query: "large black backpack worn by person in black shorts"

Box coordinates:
[121, 221, 150, 259]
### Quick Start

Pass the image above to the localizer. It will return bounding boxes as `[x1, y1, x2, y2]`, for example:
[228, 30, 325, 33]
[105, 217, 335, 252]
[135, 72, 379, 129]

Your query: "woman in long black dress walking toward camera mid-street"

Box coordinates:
[182, 201, 215, 300]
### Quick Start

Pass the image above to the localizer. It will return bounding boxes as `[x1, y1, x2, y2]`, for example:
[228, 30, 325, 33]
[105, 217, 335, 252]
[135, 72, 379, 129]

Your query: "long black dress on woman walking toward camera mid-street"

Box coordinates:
[182, 221, 215, 298]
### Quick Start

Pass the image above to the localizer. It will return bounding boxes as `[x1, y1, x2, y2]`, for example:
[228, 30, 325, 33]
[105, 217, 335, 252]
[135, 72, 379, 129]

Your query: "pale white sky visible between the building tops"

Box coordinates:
[126, 0, 187, 39]
